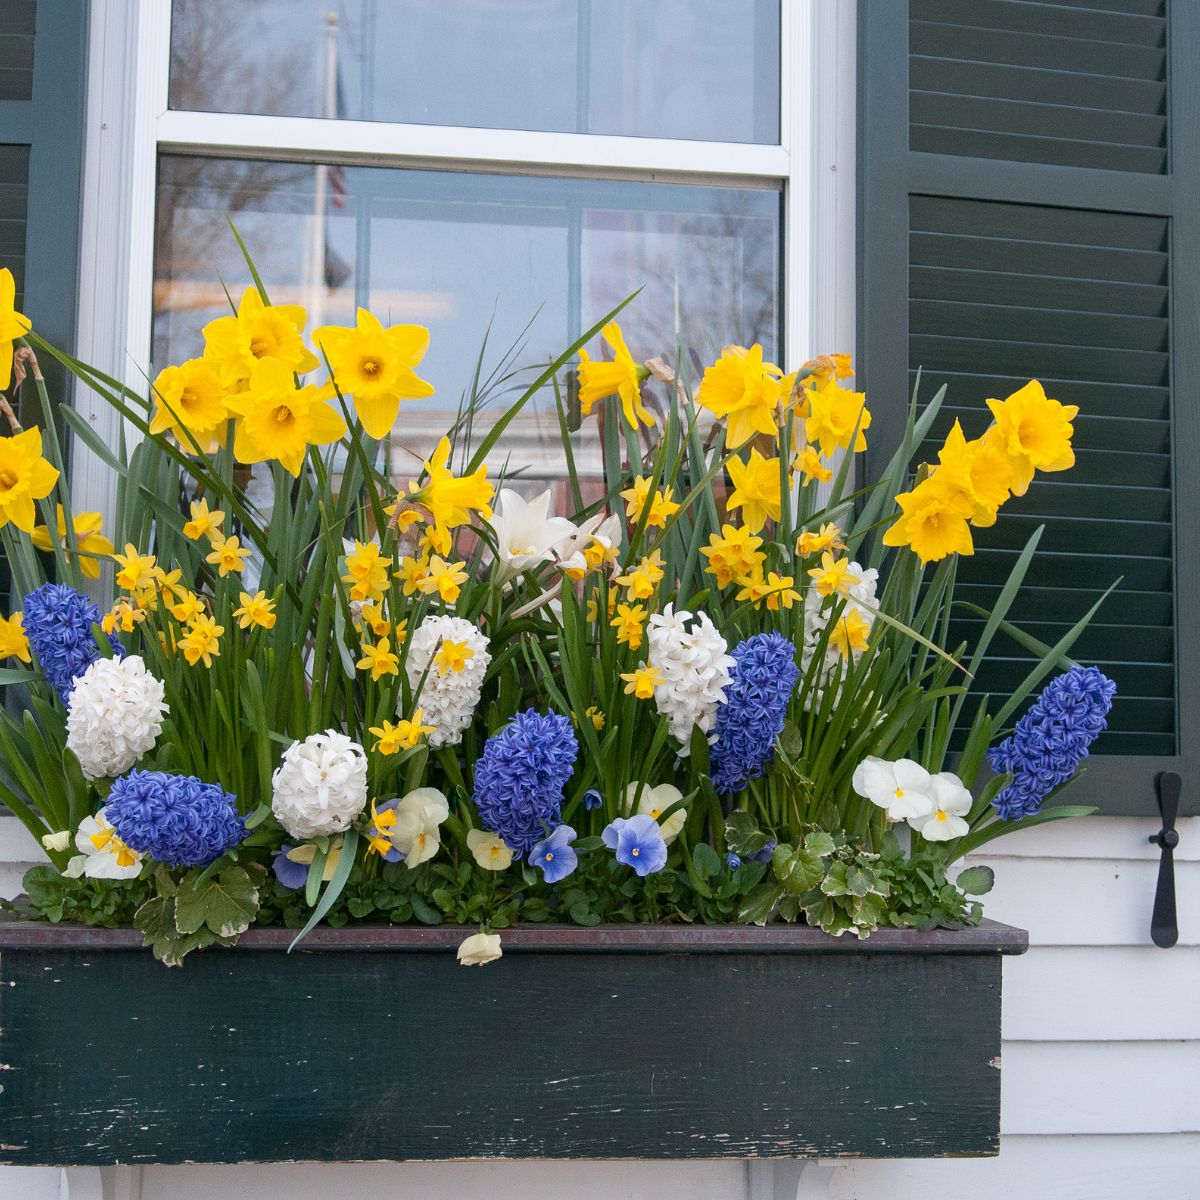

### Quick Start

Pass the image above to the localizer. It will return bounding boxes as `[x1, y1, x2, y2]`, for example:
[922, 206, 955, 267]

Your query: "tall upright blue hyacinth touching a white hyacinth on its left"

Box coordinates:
[712, 634, 800, 796]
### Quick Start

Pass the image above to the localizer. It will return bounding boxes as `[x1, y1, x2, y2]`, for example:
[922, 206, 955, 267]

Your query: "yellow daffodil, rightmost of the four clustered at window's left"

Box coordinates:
[312, 308, 433, 438]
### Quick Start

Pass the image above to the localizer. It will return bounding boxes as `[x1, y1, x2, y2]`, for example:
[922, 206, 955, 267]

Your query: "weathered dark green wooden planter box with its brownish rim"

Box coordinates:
[0, 920, 1027, 1165]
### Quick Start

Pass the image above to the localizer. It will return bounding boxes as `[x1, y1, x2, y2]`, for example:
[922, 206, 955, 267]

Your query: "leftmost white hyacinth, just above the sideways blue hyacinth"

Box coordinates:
[67, 654, 169, 779]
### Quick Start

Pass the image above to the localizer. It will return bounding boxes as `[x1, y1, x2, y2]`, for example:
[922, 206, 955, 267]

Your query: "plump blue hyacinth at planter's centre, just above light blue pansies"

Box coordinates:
[475, 709, 580, 857]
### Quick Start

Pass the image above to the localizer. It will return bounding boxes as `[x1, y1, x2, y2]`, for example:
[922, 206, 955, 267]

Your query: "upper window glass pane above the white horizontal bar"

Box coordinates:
[170, 0, 780, 143]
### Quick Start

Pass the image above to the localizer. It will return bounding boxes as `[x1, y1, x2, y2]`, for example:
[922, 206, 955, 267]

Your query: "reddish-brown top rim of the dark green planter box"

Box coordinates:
[0, 913, 1030, 954]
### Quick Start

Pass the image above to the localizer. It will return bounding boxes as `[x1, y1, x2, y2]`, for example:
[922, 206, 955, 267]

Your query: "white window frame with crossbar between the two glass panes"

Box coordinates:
[72, 0, 856, 522]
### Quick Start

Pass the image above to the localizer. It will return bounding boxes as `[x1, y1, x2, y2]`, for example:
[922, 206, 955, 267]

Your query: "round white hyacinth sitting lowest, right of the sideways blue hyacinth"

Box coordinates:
[271, 730, 367, 840]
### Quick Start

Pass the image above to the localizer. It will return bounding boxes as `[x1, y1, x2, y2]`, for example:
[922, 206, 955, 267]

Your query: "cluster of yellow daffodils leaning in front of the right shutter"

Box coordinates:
[883, 379, 1079, 563]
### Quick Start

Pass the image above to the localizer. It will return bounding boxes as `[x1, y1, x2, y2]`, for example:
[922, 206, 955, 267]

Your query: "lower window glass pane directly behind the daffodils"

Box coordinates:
[154, 156, 780, 474]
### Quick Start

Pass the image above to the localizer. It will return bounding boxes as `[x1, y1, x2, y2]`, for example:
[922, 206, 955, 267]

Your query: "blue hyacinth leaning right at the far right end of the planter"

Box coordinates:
[988, 666, 1117, 821]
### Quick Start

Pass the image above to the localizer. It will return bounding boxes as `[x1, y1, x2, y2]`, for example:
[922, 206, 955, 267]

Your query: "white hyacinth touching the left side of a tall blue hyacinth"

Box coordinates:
[646, 605, 733, 755]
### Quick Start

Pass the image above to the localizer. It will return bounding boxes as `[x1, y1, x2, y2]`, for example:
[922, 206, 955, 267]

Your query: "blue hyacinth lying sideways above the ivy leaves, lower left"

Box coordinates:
[104, 770, 246, 866]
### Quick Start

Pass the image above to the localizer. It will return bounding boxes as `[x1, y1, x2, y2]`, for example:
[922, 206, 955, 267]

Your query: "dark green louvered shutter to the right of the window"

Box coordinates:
[859, 0, 1200, 814]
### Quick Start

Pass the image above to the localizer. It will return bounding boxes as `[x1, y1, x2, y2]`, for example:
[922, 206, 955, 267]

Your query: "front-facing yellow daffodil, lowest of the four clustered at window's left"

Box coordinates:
[229, 359, 346, 476]
